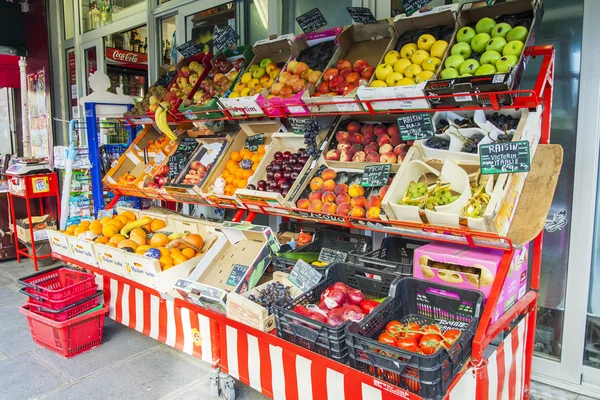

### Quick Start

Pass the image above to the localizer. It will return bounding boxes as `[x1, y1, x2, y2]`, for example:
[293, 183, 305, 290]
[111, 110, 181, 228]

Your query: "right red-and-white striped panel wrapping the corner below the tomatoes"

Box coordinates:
[219, 320, 525, 400]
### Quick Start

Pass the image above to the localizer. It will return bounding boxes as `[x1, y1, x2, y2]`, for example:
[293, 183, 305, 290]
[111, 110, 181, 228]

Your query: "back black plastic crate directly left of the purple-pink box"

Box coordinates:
[357, 236, 428, 276]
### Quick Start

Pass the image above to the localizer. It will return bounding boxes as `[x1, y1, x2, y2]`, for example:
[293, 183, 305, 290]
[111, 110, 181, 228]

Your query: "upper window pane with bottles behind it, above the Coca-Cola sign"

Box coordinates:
[79, 0, 145, 32]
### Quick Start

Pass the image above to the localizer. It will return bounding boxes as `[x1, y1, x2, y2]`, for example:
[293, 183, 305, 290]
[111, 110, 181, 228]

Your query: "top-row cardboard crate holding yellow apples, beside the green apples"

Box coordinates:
[357, 4, 459, 111]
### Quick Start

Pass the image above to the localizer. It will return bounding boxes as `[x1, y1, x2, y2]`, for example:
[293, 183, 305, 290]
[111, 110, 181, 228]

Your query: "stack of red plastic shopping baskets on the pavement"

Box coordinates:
[18, 266, 108, 358]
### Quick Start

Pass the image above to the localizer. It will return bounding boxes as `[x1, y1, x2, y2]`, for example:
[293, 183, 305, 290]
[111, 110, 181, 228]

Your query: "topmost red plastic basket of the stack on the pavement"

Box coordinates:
[18, 266, 96, 300]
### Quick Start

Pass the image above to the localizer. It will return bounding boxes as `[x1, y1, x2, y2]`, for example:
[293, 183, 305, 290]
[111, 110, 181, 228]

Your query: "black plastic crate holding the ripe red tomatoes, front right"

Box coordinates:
[346, 277, 484, 400]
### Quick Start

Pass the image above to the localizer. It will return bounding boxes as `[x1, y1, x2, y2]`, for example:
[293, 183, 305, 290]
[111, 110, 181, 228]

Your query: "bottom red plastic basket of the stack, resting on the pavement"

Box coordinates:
[21, 305, 108, 358]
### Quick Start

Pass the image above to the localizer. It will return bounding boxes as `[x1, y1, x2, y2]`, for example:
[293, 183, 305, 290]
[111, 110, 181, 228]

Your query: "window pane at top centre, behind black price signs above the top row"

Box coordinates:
[281, 0, 352, 34]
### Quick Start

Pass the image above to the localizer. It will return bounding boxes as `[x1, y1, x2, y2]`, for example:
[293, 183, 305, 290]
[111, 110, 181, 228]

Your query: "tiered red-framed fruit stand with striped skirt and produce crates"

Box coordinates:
[41, 1, 562, 400]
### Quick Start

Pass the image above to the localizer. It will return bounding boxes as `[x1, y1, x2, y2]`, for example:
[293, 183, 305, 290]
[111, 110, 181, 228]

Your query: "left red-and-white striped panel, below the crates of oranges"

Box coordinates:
[102, 276, 218, 363]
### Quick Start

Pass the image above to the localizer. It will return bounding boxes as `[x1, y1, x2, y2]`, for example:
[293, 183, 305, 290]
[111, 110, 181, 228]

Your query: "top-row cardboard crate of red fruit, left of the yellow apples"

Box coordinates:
[302, 19, 394, 113]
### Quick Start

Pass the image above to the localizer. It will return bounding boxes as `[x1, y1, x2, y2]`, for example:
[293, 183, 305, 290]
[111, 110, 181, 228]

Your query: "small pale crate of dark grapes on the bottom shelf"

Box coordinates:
[225, 271, 303, 332]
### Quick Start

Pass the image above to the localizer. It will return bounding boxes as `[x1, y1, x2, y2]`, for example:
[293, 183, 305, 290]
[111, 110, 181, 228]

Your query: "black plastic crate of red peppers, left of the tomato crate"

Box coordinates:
[273, 263, 400, 363]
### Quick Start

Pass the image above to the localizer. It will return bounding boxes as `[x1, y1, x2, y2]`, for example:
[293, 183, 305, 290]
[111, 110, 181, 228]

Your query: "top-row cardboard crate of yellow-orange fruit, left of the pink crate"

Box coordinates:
[218, 33, 295, 117]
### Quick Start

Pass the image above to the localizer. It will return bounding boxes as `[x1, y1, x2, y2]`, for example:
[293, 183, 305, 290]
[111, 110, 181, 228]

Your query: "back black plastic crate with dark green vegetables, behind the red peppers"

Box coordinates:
[272, 230, 373, 274]
